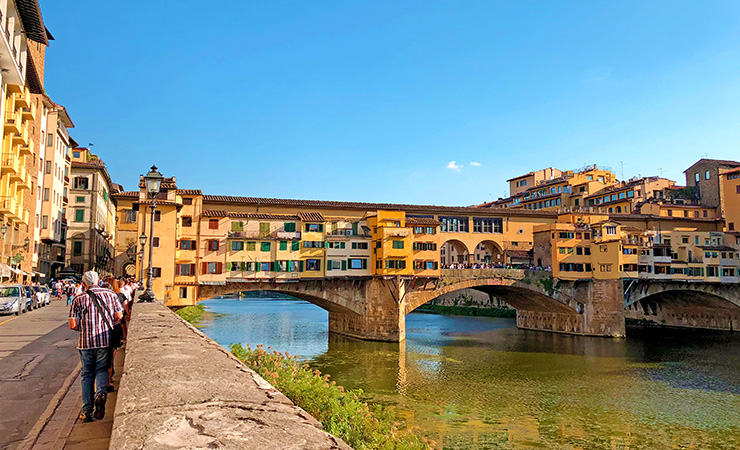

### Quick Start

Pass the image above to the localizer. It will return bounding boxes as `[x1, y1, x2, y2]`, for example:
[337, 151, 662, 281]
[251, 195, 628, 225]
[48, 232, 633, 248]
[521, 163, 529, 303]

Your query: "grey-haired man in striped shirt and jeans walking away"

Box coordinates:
[69, 270, 123, 422]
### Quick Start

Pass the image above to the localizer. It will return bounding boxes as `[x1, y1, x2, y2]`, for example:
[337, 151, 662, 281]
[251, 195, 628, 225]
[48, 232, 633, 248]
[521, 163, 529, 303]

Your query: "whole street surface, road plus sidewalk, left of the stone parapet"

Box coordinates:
[0, 300, 125, 450]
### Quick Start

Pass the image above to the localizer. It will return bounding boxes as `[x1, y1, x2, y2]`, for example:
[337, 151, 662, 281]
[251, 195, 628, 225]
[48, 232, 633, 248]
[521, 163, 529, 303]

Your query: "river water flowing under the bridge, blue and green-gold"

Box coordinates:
[195, 299, 740, 450]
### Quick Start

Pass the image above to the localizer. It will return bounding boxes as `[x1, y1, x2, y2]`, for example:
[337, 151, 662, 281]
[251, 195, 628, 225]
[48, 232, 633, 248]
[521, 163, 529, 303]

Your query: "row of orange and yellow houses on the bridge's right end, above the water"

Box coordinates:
[534, 214, 740, 283]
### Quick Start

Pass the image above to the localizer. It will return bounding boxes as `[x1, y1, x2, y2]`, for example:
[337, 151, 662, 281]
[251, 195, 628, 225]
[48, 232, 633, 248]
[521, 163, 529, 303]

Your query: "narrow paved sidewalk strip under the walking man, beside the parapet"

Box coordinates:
[26, 345, 126, 450]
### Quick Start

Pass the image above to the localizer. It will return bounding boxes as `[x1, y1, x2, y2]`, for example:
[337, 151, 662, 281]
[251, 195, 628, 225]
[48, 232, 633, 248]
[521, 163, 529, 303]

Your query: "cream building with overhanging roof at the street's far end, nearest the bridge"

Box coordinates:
[67, 147, 118, 275]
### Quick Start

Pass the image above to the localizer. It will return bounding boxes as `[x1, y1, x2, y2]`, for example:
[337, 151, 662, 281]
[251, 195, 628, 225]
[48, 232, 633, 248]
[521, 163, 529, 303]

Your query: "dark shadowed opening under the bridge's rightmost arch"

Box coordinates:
[625, 289, 740, 331]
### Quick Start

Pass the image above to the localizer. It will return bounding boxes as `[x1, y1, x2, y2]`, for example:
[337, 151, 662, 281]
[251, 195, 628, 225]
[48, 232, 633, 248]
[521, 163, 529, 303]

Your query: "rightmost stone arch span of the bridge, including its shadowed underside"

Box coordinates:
[624, 280, 740, 331]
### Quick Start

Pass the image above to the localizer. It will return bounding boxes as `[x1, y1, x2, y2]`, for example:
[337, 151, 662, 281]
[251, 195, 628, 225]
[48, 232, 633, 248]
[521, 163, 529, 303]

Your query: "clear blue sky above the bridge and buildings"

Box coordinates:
[41, 0, 740, 205]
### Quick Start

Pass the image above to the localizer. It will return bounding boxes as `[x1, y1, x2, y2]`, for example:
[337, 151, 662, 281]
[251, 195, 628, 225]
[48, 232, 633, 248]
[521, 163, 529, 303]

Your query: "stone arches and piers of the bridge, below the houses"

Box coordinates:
[199, 269, 740, 341]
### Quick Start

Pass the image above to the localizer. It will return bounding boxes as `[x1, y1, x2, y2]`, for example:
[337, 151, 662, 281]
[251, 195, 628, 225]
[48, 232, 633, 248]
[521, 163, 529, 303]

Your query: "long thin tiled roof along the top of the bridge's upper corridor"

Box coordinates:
[203, 195, 557, 217]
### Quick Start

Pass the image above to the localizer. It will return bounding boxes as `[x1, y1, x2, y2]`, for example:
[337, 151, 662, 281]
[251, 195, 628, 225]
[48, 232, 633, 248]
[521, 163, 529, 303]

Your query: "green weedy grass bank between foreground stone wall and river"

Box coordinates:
[230, 344, 429, 450]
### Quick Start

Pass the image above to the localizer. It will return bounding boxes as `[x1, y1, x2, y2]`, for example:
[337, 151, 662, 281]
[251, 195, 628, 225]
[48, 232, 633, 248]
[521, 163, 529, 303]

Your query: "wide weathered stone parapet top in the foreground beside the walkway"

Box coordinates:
[110, 303, 350, 450]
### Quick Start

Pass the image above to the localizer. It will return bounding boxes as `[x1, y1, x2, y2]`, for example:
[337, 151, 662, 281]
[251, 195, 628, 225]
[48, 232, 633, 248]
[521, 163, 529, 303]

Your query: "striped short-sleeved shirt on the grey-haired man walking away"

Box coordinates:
[69, 287, 123, 350]
